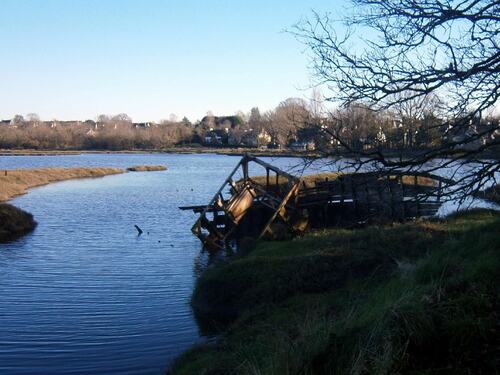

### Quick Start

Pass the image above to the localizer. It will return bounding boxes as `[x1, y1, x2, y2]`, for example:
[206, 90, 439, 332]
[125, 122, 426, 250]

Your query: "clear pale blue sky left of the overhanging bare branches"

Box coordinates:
[0, 0, 347, 121]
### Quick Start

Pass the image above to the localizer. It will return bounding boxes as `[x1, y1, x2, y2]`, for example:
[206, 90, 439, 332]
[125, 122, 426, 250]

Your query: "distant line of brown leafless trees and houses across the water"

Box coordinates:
[0, 99, 499, 155]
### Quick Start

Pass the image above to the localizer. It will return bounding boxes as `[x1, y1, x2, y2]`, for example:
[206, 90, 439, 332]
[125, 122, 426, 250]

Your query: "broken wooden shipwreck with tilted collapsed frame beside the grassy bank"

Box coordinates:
[179, 155, 450, 250]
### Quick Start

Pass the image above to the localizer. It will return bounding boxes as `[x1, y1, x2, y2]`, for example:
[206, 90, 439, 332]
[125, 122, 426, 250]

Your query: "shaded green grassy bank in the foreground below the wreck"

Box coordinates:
[171, 210, 500, 374]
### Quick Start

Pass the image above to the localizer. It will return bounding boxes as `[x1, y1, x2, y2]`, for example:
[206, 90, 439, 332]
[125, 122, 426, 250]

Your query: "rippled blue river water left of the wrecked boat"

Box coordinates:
[0, 154, 297, 374]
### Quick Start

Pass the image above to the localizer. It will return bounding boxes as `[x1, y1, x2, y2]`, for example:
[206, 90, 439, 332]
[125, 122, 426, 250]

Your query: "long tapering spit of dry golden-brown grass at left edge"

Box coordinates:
[0, 168, 125, 201]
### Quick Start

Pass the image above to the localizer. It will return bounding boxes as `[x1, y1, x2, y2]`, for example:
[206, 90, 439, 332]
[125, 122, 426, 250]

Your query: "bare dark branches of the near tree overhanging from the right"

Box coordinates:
[292, 0, 500, 203]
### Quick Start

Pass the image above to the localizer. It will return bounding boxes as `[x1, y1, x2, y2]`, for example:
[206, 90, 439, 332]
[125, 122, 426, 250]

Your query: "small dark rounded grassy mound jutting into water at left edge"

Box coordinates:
[0, 203, 36, 243]
